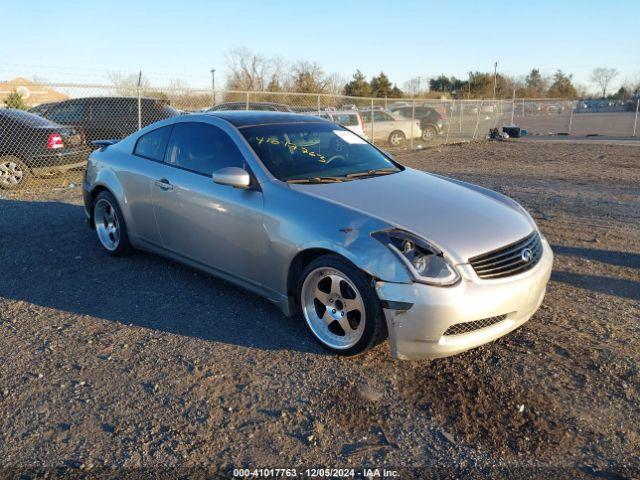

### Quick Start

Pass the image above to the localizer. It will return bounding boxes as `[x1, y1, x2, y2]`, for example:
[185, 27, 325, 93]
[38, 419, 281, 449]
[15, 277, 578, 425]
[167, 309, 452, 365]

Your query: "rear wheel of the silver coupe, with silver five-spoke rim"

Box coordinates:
[93, 190, 131, 256]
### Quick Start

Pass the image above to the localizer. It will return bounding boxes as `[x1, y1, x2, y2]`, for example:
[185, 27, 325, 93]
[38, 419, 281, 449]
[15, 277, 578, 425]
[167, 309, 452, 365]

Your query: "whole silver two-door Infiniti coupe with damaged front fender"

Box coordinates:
[83, 112, 553, 359]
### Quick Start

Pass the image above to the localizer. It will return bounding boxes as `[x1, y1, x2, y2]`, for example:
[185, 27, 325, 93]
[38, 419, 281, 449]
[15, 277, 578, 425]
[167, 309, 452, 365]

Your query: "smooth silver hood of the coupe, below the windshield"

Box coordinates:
[291, 168, 535, 263]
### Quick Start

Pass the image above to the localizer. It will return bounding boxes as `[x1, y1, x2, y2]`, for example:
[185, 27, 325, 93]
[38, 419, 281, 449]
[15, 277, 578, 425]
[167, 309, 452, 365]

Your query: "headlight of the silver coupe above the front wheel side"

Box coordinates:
[372, 229, 460, 286]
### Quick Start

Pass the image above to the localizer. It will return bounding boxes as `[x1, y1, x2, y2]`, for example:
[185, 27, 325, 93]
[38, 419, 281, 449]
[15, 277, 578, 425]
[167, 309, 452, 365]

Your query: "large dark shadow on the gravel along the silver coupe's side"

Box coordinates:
[0, 200, 326, 354]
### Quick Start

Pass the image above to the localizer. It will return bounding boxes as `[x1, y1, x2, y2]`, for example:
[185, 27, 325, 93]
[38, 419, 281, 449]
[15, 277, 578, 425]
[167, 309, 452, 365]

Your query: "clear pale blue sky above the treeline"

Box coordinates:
[0, 0, 640, 90]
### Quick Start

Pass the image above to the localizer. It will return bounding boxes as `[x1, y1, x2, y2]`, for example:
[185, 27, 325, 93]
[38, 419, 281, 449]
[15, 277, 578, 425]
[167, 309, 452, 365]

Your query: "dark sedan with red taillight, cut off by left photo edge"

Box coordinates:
[0, 108, 90, 190]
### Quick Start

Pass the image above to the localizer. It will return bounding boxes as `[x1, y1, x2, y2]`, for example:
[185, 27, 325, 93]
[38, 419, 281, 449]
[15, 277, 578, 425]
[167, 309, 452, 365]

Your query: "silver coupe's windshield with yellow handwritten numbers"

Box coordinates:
[240, 122, 402, 181]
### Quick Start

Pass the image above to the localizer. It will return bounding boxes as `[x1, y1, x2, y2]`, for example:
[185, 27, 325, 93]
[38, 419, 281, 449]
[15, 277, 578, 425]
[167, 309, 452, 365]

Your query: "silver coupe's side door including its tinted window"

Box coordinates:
[152, 122, 267, 281]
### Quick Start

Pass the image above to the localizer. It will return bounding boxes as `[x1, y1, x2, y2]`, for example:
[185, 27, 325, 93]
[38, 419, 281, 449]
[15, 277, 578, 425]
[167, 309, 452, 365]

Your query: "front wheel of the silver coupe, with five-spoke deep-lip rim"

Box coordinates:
[297, 255, 387, 356]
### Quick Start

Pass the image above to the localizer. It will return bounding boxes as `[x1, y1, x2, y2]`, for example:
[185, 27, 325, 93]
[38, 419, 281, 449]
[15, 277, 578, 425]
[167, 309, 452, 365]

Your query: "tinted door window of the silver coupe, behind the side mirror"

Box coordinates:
[165, 122, 244, 175]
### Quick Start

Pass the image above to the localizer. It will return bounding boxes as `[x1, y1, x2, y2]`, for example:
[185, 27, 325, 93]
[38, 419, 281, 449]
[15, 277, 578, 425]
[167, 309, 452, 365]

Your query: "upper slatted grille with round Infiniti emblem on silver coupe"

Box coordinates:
[469, 232, 542, 278]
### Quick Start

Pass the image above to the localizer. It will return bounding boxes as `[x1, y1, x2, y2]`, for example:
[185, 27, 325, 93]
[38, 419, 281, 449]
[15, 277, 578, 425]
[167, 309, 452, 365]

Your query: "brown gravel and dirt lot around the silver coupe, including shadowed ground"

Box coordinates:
[0, 142, 640, 479]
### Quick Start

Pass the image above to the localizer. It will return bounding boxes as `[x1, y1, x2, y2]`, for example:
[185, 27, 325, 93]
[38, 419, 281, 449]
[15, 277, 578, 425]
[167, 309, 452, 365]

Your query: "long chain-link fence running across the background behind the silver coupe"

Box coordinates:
[0, 81, 640, 195]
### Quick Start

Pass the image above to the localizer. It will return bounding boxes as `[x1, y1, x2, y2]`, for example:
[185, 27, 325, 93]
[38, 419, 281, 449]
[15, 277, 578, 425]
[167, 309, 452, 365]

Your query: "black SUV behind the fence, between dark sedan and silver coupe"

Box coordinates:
[33, 97, 179, 142]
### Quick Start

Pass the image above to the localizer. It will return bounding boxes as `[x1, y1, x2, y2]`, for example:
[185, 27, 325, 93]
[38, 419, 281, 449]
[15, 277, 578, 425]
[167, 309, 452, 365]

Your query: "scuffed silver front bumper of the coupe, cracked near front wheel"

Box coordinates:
[376, 238, 553, 360]
